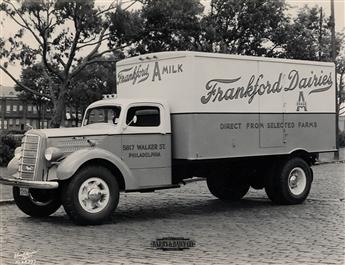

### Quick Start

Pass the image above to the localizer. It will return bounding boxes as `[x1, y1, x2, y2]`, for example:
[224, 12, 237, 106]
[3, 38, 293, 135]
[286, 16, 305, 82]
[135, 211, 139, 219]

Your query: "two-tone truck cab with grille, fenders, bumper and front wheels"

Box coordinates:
[0, 95, 172, 223]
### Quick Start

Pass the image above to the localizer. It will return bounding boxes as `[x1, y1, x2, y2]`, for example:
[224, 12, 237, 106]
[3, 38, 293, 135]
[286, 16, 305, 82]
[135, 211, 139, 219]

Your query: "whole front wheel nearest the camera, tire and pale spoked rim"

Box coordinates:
[62, 166, 119, 225]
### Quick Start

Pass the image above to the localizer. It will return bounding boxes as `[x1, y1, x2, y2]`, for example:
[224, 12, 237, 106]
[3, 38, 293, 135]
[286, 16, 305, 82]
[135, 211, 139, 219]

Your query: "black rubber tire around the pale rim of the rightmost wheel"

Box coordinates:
[265, 157, 313, 205]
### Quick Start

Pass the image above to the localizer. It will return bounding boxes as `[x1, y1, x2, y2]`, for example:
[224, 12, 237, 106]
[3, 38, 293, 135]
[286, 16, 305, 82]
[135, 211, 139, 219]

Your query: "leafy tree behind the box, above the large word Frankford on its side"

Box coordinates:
[202, 0, 287, 56]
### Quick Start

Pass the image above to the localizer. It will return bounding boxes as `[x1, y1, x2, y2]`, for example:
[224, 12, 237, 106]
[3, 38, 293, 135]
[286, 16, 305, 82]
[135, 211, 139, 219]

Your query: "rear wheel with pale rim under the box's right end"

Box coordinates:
[265, 157, 313, 204]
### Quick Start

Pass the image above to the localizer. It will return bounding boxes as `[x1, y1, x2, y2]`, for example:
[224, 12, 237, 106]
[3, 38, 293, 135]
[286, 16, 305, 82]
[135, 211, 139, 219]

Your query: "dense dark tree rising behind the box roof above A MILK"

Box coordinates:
[135, 0, 204, 53]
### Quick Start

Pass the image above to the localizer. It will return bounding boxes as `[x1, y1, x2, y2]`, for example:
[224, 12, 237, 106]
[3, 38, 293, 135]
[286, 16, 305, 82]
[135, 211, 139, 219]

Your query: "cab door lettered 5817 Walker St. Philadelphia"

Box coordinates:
[122, 103, 172, 189]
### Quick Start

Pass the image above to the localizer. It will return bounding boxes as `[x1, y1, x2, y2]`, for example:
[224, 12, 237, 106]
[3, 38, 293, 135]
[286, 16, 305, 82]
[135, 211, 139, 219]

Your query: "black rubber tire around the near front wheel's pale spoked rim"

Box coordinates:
[61, 166, 120, 225]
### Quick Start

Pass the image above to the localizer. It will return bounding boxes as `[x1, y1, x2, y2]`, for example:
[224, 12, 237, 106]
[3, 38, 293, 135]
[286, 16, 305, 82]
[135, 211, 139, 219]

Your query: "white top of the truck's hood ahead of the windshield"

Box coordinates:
[35, 123, 120, 138]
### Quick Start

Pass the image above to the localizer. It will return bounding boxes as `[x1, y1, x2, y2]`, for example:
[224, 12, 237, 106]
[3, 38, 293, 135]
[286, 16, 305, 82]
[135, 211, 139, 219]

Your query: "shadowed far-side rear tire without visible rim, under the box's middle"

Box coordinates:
[206, 171, 250, 201]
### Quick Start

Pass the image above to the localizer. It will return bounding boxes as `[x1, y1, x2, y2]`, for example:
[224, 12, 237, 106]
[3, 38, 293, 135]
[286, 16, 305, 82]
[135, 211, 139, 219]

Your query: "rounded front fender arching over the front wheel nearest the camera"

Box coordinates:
[57, 148, 138, 190]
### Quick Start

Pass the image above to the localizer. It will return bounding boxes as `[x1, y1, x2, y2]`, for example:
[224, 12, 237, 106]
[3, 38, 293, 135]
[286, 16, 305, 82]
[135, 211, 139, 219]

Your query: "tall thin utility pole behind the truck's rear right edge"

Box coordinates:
[330, 0, 339, 160]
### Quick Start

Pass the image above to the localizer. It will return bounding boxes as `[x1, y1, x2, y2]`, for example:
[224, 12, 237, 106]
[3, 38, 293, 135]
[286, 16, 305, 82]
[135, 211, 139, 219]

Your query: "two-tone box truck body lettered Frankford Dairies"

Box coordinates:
[117, 52, 336, 160]
